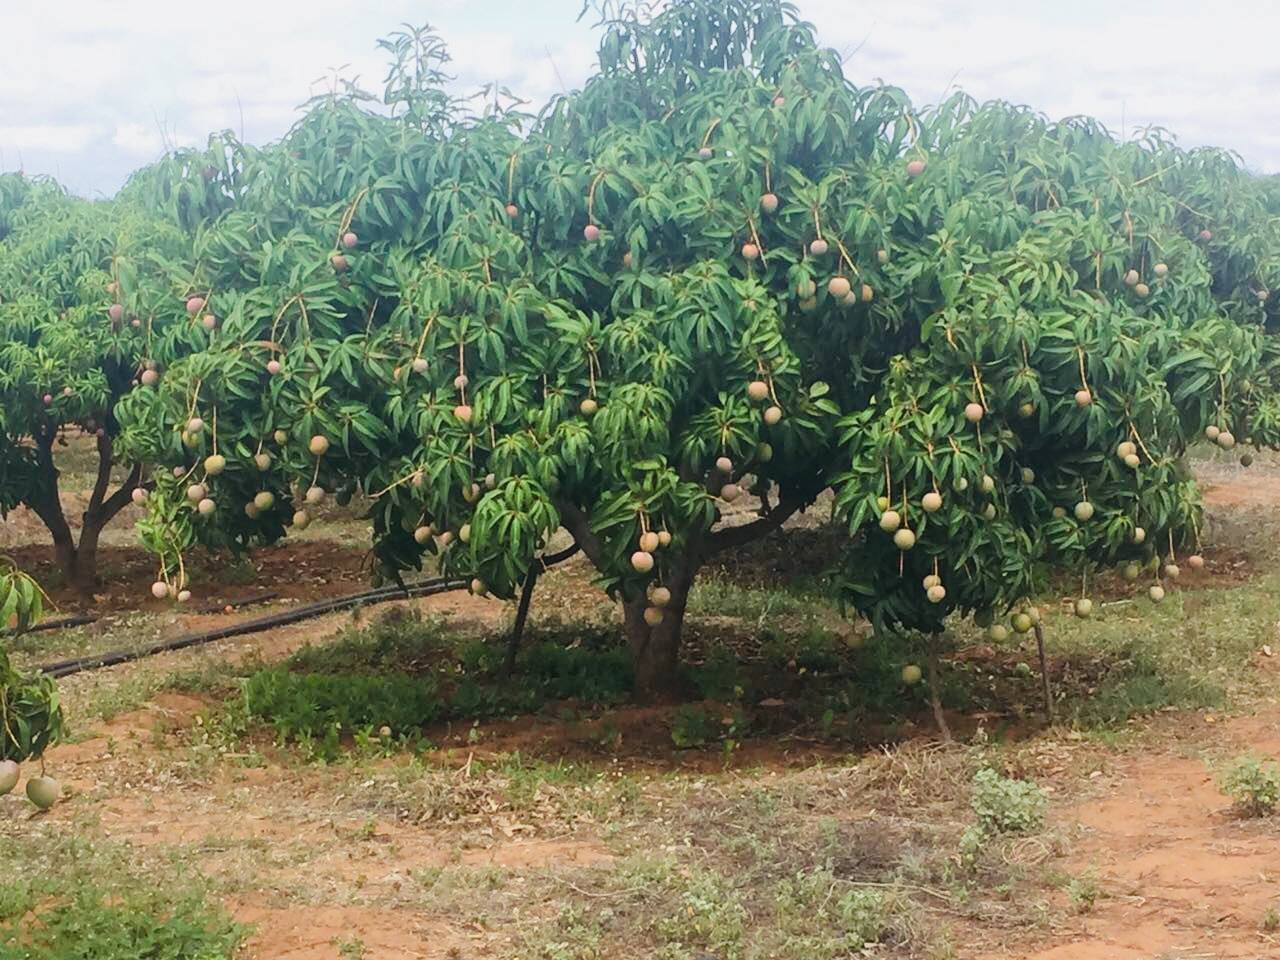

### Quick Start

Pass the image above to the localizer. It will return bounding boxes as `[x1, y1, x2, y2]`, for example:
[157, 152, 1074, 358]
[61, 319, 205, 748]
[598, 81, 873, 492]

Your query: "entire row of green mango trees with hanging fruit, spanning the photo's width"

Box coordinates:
[0, 0, 1280, 692]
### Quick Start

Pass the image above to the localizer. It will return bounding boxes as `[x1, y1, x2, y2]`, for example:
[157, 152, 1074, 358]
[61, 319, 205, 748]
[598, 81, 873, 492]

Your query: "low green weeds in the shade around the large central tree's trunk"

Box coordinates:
[239, 614, 968, 760]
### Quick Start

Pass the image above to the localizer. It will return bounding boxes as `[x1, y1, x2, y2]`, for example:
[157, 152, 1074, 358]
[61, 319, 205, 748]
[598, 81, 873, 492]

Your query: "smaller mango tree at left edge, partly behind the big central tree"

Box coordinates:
[0, 174, 214, 593]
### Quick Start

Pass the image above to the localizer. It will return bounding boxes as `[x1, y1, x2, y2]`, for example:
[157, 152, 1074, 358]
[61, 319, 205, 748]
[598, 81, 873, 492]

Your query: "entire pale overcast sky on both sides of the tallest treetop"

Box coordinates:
[0, 0, 1280, 196]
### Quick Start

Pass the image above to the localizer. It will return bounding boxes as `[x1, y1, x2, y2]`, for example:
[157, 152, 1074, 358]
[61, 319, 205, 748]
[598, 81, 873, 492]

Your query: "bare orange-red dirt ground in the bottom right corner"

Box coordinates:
[983, 712, 1280, 960]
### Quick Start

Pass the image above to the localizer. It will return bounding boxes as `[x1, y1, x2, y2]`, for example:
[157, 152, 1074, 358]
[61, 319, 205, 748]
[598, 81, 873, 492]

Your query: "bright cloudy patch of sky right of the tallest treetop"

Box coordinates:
[800, 0, 1280, 172]
